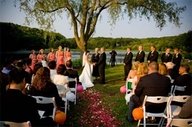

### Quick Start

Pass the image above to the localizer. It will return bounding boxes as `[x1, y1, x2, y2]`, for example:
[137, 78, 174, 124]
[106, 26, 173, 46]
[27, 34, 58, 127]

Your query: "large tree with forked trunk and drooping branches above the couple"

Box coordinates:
[15, 0, 185, 51]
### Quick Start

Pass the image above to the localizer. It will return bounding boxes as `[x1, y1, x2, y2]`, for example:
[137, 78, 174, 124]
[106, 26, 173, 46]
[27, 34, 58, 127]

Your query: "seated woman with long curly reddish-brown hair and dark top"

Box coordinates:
[28, 67, 64, 108]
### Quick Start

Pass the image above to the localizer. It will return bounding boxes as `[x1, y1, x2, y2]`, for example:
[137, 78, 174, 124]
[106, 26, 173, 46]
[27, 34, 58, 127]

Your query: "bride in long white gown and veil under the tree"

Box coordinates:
[79, 51, 94, 90]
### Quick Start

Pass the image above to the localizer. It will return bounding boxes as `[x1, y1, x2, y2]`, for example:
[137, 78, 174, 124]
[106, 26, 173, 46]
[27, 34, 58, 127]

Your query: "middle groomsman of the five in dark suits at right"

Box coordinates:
[147, 45, 159, 63]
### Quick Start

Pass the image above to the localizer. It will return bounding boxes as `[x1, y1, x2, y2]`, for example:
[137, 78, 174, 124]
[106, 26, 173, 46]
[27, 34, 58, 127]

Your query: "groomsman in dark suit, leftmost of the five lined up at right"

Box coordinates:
[123, 48, 133, 80]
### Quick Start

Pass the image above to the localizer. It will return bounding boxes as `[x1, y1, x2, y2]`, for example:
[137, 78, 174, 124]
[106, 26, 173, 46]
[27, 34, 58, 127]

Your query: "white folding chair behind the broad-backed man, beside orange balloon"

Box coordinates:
[137, 95, 169, 127]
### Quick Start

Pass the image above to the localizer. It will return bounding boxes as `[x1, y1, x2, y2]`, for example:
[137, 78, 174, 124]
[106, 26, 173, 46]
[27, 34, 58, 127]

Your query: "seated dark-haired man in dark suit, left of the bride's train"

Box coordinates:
[64, 60, 79, 87]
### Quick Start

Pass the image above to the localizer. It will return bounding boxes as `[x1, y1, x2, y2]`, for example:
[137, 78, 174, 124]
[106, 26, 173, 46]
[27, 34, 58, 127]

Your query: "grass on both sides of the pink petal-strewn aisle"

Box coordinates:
[65, 65, 135, 127]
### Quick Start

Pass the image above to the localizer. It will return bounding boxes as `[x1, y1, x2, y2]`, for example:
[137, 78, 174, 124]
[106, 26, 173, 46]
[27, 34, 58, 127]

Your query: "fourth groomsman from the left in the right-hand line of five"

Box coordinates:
[161, 48, 173, 63]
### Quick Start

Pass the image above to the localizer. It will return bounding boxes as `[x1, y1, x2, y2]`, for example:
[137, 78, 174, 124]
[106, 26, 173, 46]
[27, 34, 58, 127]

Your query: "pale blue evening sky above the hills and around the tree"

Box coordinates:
[0, 0, 192, 38]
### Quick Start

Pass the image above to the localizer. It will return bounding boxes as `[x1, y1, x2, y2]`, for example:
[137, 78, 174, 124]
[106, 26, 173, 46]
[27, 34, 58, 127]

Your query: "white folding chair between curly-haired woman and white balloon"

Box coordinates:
[56, 84, 68, 115]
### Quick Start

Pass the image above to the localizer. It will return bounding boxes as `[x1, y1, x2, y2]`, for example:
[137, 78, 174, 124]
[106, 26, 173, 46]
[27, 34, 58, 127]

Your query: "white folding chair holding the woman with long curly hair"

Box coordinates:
[32, 96, 57, 120]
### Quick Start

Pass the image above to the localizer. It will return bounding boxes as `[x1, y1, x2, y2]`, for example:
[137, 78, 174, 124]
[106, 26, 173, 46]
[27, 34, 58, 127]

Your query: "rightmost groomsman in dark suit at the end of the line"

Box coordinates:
[172, 48, 182, 79]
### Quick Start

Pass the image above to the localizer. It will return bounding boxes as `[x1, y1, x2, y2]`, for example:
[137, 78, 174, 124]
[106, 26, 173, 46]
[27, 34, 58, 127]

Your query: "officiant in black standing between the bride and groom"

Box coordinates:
[91, 48, 99, 79]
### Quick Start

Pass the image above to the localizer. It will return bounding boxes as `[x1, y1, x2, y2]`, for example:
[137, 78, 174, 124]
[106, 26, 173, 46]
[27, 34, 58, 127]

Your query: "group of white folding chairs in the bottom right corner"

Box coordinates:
[137, 95, 192, 127]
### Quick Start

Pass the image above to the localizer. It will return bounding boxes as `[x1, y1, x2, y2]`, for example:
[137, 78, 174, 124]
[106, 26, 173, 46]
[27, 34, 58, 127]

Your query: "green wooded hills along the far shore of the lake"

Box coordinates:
[0, 23, 192, 59]
